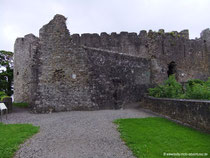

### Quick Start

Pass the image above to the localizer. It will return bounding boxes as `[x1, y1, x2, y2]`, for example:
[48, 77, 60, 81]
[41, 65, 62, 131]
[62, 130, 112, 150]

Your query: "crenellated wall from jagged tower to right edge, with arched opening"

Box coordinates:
[71, 30, 210, 83]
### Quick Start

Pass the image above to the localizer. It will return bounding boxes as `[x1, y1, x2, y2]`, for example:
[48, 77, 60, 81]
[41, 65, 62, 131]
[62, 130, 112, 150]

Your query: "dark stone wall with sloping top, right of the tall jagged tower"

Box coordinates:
[85, 48, 150, 109]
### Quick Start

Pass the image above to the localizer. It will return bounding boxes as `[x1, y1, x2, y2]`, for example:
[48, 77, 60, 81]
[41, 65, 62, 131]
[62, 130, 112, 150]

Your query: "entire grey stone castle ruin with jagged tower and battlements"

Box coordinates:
[14, 15, 210, 112]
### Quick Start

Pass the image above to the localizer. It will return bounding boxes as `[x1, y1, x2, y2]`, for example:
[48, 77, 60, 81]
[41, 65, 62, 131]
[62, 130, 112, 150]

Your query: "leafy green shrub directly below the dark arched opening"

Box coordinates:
[149, 75, 183, 98]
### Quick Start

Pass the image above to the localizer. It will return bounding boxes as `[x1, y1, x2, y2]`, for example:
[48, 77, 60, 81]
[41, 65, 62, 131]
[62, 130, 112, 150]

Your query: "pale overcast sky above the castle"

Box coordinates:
[0, 0, 210, 51]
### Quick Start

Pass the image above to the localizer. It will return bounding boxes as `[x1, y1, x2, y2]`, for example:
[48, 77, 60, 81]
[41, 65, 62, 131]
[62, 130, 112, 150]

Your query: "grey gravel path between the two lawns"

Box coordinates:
[4, 109, 154, 158]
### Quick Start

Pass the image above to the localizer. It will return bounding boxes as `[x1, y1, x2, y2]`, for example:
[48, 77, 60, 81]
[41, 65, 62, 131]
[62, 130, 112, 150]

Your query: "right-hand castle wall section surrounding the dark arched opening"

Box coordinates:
[148, 32, 209, 83]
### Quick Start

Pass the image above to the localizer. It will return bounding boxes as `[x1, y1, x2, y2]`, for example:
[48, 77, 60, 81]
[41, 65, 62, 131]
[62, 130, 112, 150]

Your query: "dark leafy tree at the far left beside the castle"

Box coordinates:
[0, 50, 13, 96]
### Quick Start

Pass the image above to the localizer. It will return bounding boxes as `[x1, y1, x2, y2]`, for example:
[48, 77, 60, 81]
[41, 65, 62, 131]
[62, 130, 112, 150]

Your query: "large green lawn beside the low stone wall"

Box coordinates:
[114, 117, 210, 158]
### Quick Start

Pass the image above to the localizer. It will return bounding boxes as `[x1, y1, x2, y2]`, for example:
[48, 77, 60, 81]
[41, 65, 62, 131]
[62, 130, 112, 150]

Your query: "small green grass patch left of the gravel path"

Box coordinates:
[0, 123, 39, 158]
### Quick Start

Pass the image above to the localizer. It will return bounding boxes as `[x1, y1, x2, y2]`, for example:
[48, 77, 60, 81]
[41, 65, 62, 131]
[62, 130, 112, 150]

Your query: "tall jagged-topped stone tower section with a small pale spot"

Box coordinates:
[34, 15, 97, 112]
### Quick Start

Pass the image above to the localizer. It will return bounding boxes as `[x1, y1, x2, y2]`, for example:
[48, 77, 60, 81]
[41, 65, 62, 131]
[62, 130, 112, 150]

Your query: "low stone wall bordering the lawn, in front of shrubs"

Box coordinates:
[141, 96, 210, 133]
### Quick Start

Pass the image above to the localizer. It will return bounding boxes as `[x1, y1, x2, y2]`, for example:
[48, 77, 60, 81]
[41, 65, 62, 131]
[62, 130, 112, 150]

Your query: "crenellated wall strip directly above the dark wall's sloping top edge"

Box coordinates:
[71, 32, 149, 58]
